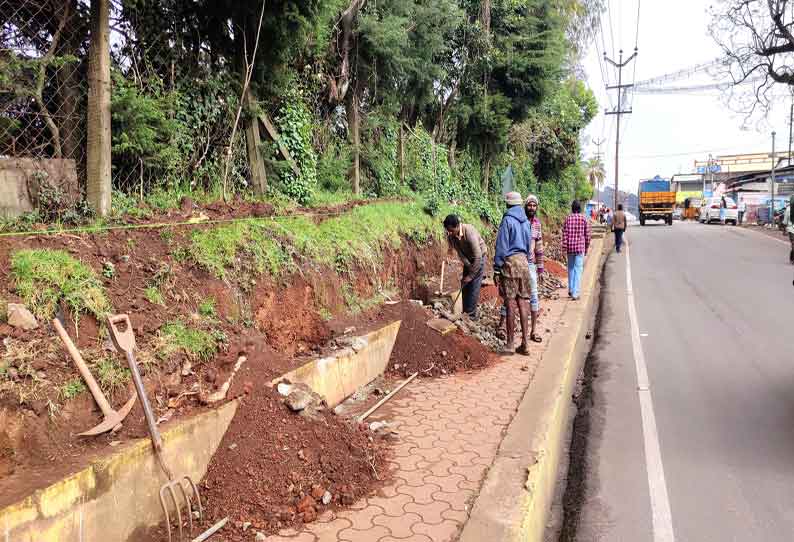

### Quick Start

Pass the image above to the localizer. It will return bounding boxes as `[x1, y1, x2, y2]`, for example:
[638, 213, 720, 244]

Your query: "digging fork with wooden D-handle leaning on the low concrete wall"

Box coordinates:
[108, 314, 203, 542]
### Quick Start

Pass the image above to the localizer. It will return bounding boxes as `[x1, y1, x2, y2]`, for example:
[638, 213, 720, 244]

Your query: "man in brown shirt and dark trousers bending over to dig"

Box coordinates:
[444, 214, 487, 320]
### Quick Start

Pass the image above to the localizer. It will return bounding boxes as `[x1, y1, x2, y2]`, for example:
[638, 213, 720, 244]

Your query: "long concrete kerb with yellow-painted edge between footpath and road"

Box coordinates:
[459, 236, 613, 542]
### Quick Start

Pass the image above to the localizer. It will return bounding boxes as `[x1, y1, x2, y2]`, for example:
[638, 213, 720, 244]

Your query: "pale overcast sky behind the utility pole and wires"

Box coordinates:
[583, 0, 790, 196]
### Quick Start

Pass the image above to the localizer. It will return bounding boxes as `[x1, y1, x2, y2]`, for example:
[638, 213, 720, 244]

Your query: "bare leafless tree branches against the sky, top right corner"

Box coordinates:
[710, 0, 794, 114]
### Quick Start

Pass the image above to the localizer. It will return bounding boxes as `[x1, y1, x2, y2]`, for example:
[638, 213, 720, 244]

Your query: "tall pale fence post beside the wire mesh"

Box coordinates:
[86, 0, 111, 216]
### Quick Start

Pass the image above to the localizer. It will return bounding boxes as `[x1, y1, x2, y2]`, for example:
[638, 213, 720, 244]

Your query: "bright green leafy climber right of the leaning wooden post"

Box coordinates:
[273, 92, 317, 205]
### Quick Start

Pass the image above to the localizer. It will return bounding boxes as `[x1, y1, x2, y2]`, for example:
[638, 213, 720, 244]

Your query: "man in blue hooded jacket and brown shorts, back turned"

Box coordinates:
[494, 192, 532, 355]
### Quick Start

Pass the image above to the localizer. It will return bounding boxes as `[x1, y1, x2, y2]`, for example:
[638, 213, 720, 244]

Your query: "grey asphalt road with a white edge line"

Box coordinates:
[563, 222, 794, 542]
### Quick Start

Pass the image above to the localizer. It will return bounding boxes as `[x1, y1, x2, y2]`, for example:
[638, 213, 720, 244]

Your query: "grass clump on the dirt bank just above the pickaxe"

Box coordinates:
[11, 249, 111, 322]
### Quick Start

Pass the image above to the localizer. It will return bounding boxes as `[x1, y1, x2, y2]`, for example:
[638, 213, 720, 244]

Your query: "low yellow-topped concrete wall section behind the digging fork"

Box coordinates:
[0, 401, 237, 542]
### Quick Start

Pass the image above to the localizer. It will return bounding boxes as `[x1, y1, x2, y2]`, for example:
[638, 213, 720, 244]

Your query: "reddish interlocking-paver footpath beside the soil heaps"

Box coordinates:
[267, 300, 568, 542]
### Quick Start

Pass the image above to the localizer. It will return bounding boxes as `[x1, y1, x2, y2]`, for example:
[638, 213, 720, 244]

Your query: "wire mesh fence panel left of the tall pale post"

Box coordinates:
[0, 0, 89, 171]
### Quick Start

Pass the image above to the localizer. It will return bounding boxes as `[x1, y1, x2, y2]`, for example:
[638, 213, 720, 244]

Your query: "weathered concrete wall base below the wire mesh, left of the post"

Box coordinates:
[0, 158, 80, 217]
